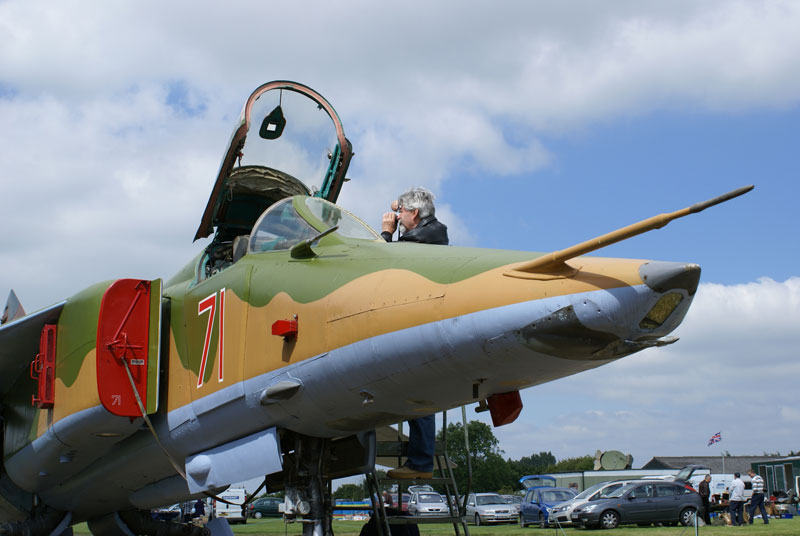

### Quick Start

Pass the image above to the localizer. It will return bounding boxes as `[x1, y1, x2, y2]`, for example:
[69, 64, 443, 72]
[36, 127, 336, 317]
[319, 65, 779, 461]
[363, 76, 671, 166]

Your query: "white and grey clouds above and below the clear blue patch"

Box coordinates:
[0, 0, 800, 461]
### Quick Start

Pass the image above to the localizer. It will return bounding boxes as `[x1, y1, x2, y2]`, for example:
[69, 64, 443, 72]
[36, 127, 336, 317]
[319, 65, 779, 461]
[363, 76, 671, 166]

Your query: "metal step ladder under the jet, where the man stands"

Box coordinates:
[365, 412, 469, 536]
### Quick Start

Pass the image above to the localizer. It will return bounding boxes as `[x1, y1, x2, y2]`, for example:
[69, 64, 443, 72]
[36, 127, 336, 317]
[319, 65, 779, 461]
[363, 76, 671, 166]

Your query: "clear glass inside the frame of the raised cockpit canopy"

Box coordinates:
[239, 89, 338, 195]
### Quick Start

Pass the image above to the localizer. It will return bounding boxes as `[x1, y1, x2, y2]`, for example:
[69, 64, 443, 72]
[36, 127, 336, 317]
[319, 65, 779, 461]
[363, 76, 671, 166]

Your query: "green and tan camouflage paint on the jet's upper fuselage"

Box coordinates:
[9, 198, 642, 450]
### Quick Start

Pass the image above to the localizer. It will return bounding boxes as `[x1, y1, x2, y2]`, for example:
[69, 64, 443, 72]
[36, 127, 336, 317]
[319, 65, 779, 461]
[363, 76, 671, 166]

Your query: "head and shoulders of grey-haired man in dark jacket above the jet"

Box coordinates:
[381, 188, 449, 246]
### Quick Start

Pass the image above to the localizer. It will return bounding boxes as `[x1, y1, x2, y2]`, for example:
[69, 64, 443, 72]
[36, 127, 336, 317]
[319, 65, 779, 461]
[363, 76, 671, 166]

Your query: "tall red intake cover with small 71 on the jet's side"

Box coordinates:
[97, 279, 151, 417]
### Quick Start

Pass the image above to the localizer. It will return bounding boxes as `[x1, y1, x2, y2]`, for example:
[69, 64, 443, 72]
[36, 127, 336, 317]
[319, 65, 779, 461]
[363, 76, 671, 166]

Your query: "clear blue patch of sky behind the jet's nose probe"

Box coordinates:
[441, 107, 800, 284]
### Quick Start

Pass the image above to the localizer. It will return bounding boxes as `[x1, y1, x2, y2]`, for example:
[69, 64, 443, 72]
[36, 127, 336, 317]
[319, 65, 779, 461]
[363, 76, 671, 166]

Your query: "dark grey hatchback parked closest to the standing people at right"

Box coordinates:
[570, 481, 703, 529]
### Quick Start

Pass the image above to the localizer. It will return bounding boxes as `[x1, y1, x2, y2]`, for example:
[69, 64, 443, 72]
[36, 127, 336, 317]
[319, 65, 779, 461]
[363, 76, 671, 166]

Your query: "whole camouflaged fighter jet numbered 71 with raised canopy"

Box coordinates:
[0, 81, 752, 535]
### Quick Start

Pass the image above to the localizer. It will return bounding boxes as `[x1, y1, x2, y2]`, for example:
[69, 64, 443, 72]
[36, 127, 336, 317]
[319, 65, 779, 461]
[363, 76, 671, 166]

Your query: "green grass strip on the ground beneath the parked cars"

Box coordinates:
[75, 517, 800, 536]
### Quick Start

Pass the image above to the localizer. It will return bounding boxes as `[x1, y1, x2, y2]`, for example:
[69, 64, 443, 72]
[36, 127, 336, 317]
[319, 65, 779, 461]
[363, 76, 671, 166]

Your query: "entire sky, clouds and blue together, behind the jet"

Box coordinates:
[0, 0, 800, 480]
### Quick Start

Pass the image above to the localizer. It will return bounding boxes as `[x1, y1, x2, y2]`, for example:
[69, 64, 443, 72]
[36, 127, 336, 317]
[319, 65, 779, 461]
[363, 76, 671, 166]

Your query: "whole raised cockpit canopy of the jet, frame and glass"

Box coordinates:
[195, 81, 352, 242]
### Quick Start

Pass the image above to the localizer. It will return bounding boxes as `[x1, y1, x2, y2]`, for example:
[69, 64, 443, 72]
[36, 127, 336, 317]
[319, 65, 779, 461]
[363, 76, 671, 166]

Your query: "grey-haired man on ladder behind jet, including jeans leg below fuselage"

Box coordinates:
[381, 188, 450, 479]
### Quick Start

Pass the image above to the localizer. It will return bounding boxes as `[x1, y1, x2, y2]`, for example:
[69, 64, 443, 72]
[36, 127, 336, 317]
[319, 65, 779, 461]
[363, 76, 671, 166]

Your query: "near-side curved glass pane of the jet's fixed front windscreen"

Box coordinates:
[250, 197, 319, 253]
